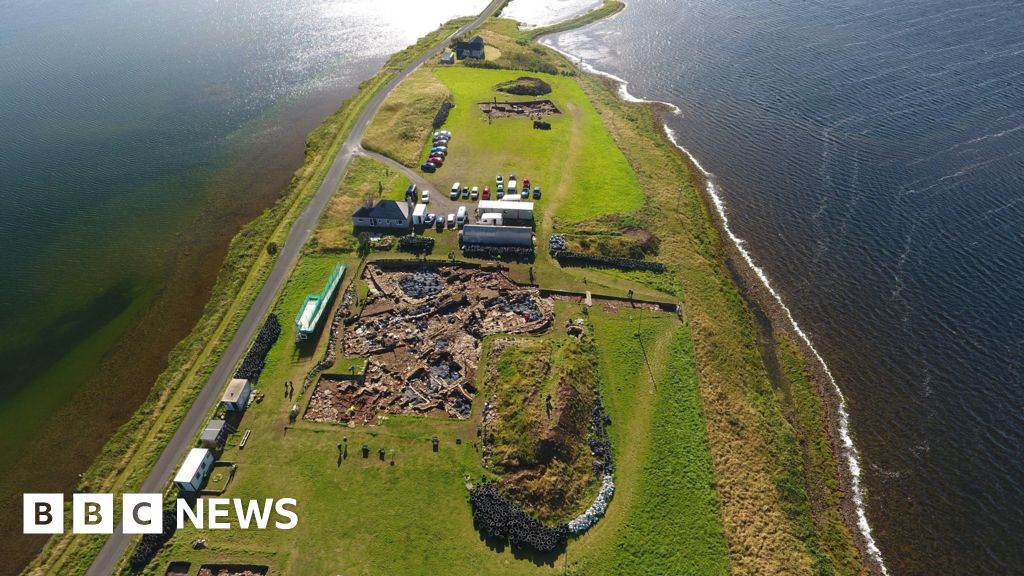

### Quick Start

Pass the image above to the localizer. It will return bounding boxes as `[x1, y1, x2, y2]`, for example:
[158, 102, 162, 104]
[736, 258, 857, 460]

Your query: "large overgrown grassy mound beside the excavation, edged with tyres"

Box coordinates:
[485, 337, 598, 522]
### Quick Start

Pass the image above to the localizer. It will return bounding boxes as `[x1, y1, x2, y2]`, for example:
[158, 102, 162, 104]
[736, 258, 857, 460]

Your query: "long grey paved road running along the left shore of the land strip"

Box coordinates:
[86, 0, 503, 576]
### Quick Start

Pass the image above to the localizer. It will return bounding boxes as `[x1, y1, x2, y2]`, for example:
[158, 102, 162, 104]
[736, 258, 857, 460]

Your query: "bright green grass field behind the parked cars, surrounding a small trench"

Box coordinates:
[424, 68, 643, 220]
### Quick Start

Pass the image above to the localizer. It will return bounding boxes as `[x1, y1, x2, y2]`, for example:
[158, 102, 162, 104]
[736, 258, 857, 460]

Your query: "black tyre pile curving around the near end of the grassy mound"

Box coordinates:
[469, 482, 569, 552]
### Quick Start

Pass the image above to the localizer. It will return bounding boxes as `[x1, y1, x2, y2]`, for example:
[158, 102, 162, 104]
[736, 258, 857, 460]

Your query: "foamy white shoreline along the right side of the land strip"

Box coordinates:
[537, 11, 889, 576]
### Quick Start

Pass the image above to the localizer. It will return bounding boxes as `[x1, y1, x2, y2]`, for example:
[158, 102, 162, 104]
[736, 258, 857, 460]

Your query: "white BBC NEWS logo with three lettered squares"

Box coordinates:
[22, 494, 299, 534]
